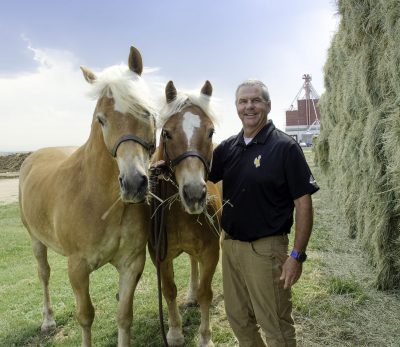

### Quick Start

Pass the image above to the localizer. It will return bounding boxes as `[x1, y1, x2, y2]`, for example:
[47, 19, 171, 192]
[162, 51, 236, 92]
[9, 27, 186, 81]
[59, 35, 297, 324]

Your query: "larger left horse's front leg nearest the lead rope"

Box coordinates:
[117, 250, 146, 347]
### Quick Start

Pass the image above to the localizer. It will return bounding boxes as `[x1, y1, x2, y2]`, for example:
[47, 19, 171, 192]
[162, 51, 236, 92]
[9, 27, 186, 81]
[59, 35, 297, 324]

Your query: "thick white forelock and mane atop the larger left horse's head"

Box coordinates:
[89, 65, 157, 122]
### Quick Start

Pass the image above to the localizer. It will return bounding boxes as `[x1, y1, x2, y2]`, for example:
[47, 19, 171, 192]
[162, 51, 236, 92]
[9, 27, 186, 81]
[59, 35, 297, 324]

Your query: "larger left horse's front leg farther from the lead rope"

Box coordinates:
[68, 257, 94, 347]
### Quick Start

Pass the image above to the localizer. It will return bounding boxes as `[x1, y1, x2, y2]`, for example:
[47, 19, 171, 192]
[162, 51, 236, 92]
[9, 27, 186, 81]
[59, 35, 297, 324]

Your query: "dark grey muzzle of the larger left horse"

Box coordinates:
[118, 173, 149, 203]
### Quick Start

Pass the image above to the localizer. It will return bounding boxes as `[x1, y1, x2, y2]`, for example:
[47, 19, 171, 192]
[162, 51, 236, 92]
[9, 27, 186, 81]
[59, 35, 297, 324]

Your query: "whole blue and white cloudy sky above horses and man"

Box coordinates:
[0, 0, 340, 152]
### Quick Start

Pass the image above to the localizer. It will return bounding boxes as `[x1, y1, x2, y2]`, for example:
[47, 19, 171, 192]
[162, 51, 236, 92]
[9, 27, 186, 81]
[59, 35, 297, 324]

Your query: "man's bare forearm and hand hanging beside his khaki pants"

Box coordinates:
[280, 194, 313, 289]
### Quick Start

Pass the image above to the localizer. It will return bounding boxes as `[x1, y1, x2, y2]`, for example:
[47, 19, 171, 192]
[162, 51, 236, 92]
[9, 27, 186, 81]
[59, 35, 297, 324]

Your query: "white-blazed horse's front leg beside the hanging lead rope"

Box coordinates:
[161, 260, 185, 346]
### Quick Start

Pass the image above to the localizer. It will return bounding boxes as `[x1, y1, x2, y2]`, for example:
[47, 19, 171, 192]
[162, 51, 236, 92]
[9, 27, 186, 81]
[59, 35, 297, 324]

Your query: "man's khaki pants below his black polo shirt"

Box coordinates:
[222, 235, 296, 347]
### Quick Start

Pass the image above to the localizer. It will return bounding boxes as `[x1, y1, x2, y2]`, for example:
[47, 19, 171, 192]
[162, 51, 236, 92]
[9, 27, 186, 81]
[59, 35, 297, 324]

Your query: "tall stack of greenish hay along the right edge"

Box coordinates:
[316, 0, 400, 289]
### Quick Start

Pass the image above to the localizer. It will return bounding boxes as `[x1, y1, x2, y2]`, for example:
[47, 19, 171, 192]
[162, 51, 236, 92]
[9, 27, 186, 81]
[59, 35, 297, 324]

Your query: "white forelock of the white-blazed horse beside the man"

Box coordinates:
[159, 93, 218, 128]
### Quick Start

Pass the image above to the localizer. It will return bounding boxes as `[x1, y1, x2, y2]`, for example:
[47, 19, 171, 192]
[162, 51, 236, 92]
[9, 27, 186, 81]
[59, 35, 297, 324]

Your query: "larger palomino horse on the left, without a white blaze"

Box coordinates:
[19, 47, 155, 346]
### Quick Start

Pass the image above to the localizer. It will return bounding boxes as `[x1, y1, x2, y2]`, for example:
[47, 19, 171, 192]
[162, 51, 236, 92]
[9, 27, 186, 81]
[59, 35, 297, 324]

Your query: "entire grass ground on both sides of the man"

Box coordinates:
[0, 149, 400, 347]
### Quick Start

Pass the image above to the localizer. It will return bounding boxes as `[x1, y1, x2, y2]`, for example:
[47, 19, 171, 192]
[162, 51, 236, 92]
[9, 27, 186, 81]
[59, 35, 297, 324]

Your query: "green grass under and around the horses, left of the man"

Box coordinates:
[0, 204, 234, 347]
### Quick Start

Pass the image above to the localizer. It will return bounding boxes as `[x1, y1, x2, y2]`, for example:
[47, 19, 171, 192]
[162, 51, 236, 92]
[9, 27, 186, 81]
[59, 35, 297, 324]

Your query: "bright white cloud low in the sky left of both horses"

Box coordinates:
[0, 44, 94, 151]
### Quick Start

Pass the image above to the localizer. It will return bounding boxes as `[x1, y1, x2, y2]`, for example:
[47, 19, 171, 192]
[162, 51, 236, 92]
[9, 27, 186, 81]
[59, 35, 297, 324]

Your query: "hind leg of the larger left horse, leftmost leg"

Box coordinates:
[32, 237, 56, 333]
